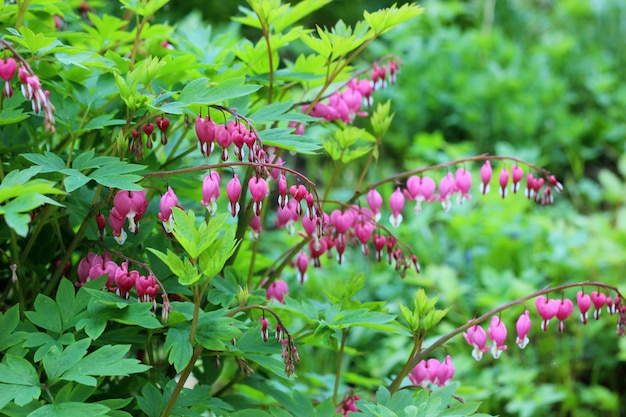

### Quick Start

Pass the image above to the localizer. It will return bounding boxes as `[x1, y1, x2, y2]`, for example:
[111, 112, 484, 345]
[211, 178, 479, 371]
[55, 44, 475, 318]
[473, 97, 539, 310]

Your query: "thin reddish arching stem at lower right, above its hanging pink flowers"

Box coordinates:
[389, 281, 624, 394]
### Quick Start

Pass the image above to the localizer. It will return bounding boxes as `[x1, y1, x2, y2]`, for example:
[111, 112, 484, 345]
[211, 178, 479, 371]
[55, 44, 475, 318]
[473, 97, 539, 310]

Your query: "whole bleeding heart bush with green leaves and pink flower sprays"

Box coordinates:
[0, 0, 626, 417]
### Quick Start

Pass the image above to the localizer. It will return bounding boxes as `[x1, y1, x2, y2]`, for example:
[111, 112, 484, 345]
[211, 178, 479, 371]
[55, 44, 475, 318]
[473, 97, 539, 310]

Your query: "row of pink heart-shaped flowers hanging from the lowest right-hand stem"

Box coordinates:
[463, 290, 626, 360]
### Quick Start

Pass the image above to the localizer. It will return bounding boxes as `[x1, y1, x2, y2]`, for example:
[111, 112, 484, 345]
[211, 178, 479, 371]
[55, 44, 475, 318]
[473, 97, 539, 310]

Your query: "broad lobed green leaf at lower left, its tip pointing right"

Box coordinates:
[61, 345, 150, 386]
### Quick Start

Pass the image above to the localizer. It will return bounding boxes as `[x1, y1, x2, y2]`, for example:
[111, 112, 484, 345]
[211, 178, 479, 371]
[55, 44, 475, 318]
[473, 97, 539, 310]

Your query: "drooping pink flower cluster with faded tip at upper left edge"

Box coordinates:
[0, 49, 55, 133]
